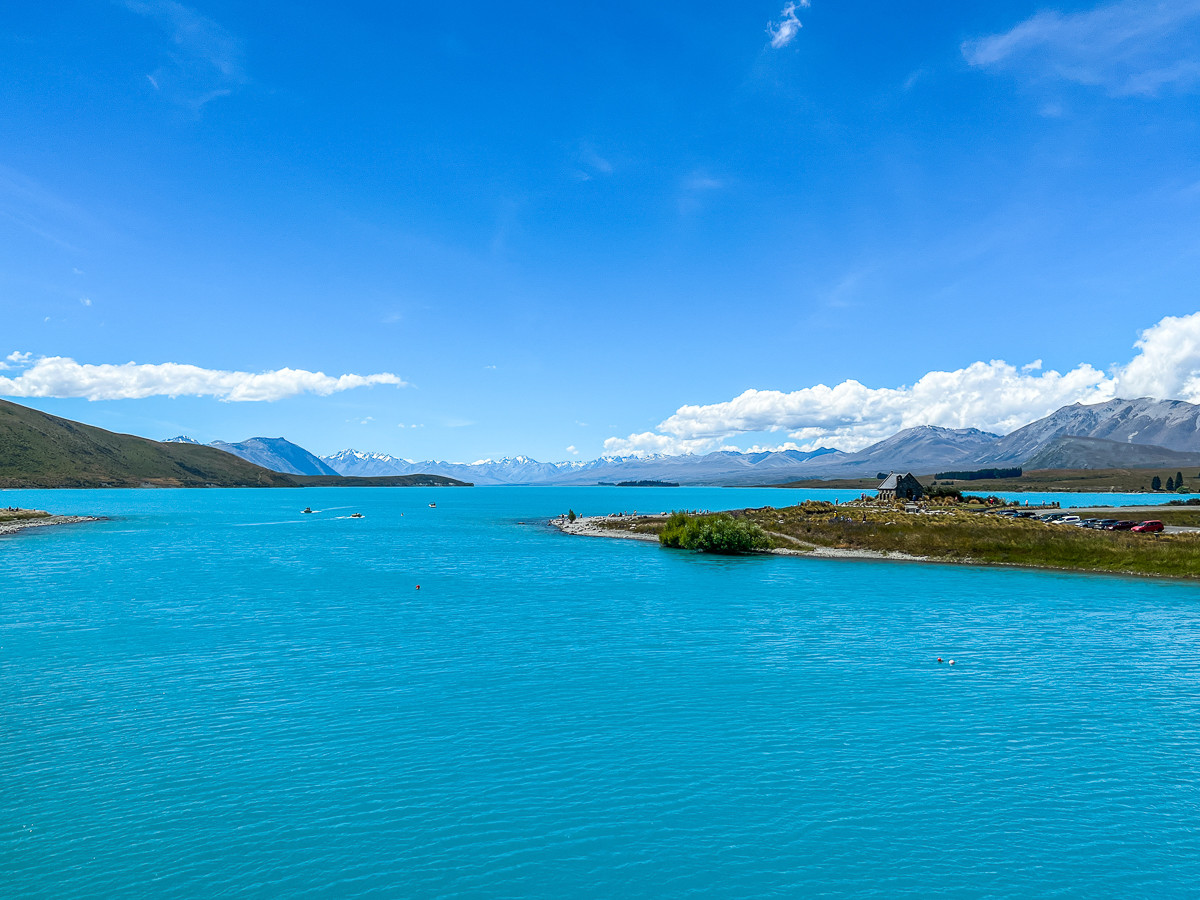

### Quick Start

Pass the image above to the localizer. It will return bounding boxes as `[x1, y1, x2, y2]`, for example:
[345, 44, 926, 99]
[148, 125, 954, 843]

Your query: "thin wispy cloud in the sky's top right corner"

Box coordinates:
[962, 0, 1200, 96]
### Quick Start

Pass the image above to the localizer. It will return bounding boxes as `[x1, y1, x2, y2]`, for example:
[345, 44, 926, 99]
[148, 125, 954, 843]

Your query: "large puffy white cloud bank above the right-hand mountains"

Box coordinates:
[605, 312, 1200, 454]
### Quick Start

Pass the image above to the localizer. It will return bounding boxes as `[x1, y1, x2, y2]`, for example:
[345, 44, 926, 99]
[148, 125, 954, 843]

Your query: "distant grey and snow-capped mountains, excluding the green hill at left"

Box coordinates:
[307, 397, 1200, 485]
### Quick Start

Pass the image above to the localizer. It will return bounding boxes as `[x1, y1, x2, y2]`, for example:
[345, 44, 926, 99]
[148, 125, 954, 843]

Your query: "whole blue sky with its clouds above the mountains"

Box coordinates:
[0, 0, 1200, 461]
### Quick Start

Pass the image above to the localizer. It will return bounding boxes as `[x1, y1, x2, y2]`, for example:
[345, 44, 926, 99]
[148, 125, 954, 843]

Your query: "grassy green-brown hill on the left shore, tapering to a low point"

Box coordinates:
[0, 400, 463, 487]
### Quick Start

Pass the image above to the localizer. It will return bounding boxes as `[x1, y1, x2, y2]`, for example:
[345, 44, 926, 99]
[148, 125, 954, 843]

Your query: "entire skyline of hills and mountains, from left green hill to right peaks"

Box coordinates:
[9, 398, 1200, 487]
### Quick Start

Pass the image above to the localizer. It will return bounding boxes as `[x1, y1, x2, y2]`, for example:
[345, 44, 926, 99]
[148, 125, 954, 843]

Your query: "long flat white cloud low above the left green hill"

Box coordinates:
[0, 354, 406, 401]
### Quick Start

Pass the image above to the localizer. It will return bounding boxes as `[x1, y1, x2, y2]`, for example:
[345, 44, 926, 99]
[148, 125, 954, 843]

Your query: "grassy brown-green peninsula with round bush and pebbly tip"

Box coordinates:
[551, 499, 1200, 578]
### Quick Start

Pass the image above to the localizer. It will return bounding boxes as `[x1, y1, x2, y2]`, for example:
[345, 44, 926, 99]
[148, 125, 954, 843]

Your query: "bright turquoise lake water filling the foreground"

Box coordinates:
[0, 487, 1200, 900]
